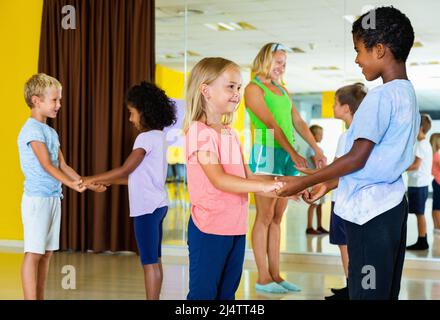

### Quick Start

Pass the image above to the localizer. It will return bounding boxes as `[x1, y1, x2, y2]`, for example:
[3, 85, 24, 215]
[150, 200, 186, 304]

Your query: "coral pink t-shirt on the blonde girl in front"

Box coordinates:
[185, 121, 248, 235]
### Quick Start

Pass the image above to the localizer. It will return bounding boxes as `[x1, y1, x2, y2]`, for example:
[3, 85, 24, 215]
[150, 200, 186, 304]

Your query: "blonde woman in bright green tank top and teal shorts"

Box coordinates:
[244, 43, 326, 293]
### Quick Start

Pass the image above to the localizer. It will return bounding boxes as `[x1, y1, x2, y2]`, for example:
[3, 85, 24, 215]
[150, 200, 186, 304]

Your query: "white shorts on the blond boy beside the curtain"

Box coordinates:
[21, 194, 61, 254]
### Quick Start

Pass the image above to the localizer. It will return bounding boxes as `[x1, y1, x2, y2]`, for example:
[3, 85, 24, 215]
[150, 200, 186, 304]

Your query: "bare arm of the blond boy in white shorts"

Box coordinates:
[30, 141, 86, 192]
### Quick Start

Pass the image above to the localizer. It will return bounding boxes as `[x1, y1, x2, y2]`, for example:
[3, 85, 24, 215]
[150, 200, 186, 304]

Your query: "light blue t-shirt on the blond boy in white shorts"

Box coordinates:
[17, 118, 62, 197]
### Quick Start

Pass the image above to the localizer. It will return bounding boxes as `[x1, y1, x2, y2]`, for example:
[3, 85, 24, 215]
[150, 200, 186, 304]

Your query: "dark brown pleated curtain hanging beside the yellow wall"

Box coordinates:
[39, 0, 155, 252]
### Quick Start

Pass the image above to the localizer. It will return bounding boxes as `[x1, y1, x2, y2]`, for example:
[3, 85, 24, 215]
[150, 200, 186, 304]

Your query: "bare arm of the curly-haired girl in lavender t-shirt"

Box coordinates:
[83, 148, 145, 186]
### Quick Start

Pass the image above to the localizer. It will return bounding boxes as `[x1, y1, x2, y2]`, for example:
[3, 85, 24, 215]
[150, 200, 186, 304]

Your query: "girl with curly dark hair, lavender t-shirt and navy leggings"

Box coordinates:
[83, 82, 176, 300]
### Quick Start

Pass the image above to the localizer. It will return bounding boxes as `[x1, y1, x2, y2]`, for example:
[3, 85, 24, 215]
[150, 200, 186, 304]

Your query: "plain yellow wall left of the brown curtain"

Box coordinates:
[0, 0, 43, 240]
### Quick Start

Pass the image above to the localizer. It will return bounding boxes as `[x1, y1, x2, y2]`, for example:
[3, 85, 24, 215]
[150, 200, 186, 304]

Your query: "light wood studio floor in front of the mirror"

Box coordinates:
[0, 252, 440, 300]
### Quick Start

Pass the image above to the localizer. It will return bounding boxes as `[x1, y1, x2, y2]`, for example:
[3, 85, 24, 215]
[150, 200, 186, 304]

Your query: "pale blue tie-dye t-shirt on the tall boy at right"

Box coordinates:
[335, 80, 420, 225]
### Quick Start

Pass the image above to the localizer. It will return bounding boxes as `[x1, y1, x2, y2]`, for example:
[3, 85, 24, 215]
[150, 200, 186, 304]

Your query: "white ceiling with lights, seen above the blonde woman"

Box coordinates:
[156, 0, 440, 109]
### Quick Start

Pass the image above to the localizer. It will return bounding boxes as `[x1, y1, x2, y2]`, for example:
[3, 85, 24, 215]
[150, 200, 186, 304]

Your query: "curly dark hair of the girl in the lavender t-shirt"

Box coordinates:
[125, 81, 176, 130]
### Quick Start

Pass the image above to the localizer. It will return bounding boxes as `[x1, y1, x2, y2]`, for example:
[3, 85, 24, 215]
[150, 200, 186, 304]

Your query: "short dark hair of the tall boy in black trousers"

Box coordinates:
[352, 6, 414, 62]
